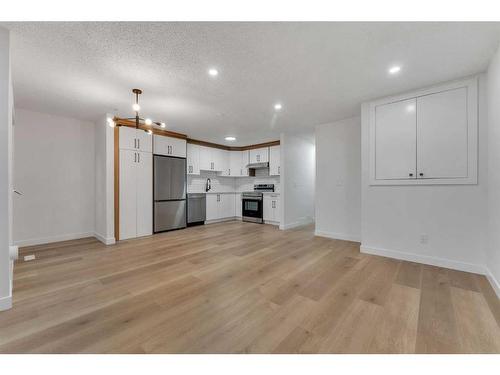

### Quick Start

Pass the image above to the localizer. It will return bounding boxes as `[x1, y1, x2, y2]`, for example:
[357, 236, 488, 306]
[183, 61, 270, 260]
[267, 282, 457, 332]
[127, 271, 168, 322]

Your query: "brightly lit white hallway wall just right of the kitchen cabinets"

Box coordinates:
[280, 133, 316, 229]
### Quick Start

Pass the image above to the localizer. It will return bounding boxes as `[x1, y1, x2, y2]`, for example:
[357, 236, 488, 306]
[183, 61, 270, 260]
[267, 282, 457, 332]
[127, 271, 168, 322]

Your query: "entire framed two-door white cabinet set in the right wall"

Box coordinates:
[369, 78, 478, 185]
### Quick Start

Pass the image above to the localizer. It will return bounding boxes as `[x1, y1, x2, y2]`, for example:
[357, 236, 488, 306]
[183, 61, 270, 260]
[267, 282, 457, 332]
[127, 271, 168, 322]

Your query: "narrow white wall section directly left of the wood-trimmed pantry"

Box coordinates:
[95, 115, 115, 245]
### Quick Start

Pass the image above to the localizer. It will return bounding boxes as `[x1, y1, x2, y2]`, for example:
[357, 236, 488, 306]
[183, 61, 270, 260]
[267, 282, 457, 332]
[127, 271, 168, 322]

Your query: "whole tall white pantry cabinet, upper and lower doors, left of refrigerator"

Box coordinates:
[118, 126, 153, 240]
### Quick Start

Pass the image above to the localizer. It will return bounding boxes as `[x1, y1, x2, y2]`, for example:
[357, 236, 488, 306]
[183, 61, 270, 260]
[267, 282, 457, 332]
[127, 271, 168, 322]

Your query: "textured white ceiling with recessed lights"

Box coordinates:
[0, 22, 500, 145]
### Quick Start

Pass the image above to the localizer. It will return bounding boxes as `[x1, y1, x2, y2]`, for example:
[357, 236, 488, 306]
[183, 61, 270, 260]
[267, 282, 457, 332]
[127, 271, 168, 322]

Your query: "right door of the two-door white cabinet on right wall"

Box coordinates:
[417, 87, 467, 178]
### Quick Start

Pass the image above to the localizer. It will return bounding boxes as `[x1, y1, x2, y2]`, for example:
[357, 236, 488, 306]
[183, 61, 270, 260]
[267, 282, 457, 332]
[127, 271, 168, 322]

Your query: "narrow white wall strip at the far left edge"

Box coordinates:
[0, 28, 13, 311]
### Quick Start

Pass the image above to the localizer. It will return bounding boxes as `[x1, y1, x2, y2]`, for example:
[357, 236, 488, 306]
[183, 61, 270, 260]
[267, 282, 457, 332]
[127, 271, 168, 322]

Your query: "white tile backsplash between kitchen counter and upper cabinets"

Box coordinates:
[187, 169, 280, 193]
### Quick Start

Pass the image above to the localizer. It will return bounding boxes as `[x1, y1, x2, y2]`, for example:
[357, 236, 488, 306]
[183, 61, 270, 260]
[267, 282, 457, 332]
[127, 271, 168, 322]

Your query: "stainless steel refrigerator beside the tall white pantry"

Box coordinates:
[153, 155, 186, 233]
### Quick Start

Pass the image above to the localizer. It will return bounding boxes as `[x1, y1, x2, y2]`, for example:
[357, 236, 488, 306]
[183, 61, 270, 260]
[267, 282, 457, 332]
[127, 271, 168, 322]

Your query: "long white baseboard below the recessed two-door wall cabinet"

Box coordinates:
[360, 245, 487, 275]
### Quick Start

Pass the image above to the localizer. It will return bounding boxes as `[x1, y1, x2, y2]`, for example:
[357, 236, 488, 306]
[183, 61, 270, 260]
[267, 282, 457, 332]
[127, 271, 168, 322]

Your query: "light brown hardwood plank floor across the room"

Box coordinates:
[0, 222, 500, 353]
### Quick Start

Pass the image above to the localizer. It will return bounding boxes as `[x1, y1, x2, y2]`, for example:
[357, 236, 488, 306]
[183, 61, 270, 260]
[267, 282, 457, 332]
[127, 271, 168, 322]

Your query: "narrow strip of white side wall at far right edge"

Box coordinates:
[486, 45, 500, 298]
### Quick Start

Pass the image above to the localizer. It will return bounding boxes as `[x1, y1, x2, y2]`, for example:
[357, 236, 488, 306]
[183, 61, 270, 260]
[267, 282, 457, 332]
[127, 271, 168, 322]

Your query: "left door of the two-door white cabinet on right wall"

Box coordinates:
[375, 99, 417, 180]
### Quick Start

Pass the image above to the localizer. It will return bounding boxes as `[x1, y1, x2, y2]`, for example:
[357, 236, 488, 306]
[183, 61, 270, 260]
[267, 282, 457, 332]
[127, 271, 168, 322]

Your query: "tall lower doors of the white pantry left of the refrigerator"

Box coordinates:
[119, 150, 153, 240]
